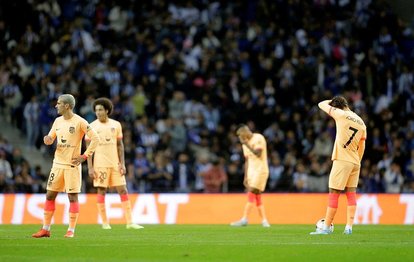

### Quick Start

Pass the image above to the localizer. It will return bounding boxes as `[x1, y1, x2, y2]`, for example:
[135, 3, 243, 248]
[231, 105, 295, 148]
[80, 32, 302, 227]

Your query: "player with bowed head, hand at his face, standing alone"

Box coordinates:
[230, 125, 270, 227]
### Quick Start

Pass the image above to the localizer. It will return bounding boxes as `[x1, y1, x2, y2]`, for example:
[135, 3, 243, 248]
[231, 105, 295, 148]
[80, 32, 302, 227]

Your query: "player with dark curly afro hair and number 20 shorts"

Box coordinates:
[86, 98, 144, 229]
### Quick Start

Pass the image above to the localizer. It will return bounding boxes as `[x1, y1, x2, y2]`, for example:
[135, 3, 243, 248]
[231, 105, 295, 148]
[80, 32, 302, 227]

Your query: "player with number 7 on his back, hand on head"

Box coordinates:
[311, 96, 367, 235]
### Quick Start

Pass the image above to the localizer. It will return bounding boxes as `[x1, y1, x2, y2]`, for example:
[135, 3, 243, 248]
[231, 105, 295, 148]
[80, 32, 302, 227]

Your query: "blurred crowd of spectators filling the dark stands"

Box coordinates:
[0, 0, 414, 193]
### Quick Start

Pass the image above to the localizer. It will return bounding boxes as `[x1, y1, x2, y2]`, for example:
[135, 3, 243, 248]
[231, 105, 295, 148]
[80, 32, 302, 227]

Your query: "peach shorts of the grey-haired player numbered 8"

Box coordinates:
[46, 165, 82, 193]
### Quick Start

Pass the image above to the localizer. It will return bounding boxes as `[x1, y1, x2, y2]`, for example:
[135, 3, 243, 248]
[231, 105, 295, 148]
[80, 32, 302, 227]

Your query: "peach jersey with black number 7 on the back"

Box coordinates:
[328, 107, 367, 165]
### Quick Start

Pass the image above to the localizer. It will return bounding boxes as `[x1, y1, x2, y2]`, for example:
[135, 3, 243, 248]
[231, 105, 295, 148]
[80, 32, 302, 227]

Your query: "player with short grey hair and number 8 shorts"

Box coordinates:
[32, 94, 99, 238]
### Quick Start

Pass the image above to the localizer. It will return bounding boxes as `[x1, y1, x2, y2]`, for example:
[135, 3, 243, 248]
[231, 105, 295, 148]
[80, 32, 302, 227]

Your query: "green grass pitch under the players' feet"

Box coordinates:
[0, 225, 414, 262]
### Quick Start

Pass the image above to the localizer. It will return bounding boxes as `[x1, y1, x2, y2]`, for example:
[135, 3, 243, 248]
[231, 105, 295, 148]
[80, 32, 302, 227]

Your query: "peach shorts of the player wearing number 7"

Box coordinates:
[329, 160, 361, 190]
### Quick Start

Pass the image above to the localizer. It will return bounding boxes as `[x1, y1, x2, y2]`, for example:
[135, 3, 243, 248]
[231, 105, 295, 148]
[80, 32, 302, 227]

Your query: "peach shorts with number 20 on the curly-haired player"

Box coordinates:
[93, 167, 126, 188]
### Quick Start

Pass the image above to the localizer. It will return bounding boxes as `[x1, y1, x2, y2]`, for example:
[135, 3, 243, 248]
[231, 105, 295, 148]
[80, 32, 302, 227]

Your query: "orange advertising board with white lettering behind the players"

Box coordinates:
[0, 193, 414, 224]
